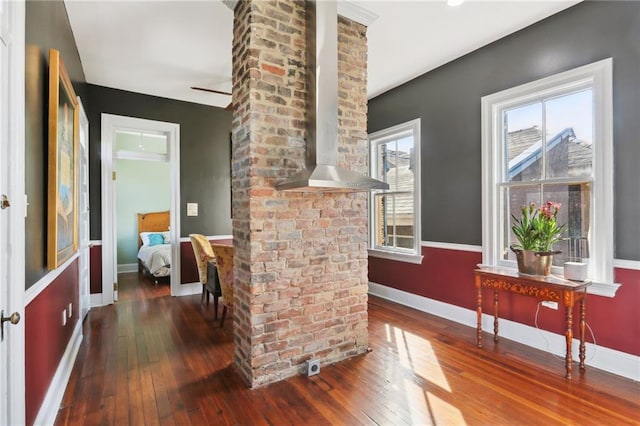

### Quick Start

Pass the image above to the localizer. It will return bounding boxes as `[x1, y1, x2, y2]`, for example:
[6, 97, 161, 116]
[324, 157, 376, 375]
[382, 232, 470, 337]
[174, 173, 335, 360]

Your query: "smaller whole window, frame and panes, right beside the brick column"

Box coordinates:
[369, 119, 422, 263]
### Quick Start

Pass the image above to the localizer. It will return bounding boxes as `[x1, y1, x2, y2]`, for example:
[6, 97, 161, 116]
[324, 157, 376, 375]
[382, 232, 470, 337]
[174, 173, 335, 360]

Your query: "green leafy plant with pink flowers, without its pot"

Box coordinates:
[511, 201, 565, 252]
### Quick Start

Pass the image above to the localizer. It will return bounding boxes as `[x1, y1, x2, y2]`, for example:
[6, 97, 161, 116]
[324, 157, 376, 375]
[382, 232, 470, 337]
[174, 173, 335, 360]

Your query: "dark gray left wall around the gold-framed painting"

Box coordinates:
[25, 1, 89, 288]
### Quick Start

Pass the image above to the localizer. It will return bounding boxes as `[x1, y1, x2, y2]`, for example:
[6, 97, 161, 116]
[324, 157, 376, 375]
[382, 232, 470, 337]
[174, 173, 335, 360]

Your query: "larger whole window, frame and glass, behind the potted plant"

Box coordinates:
[482, 59, 613, 293]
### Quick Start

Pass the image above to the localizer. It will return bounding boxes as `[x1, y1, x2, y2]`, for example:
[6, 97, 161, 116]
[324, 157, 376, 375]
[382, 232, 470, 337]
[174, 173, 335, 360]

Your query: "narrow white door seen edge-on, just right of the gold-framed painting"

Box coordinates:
[78, 98, 91, 321]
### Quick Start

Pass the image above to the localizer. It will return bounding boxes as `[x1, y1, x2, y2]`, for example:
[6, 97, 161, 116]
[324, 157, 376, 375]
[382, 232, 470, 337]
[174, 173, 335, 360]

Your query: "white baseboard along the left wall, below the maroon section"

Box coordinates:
[33, 320, 82, 425]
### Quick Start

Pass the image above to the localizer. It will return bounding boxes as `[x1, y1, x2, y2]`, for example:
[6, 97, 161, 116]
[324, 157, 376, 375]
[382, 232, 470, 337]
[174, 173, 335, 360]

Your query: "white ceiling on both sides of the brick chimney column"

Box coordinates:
[65, 0, 578, 108]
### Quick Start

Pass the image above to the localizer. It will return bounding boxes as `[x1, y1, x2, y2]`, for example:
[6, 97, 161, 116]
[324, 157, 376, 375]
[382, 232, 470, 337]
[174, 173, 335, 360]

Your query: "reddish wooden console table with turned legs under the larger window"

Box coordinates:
[474, 267, 591, 379]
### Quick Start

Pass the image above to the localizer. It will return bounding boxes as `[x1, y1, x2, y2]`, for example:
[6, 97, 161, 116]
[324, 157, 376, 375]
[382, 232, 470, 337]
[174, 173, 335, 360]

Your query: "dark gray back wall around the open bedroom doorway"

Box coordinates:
[88, 84, 232, 240]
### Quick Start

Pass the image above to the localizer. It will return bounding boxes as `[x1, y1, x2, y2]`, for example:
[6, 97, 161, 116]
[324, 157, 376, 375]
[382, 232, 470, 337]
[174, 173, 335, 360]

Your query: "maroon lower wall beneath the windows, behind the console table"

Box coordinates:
[369, 247, 640, 356]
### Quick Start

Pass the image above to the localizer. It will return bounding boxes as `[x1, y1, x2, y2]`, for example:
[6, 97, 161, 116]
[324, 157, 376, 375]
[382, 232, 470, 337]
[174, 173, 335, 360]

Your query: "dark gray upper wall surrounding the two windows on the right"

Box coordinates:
[368, 1, 640, 260]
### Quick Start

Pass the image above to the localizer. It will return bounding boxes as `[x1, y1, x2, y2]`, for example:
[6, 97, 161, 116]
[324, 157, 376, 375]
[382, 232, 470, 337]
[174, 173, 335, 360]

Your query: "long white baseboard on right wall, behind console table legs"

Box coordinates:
[369, 282, 640, 381]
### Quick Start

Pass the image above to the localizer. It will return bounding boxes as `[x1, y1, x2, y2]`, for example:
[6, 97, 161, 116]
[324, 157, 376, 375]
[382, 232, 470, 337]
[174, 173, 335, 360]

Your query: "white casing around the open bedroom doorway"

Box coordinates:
[101, 113, 181, 305]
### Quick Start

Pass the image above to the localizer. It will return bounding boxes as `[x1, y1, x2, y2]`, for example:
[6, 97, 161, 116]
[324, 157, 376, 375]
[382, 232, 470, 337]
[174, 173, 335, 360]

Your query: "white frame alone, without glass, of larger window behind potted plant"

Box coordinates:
[482, 58, 619, 297]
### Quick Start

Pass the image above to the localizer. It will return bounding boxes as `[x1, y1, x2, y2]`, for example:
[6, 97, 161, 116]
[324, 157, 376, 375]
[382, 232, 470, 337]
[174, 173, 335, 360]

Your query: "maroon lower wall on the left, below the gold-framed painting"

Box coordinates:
[25, 259, 79, 424]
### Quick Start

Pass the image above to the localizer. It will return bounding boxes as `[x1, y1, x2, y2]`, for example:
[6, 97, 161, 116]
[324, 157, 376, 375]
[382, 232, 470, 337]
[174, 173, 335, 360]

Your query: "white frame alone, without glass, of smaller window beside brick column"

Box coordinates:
[369, 118, 423, 264]
